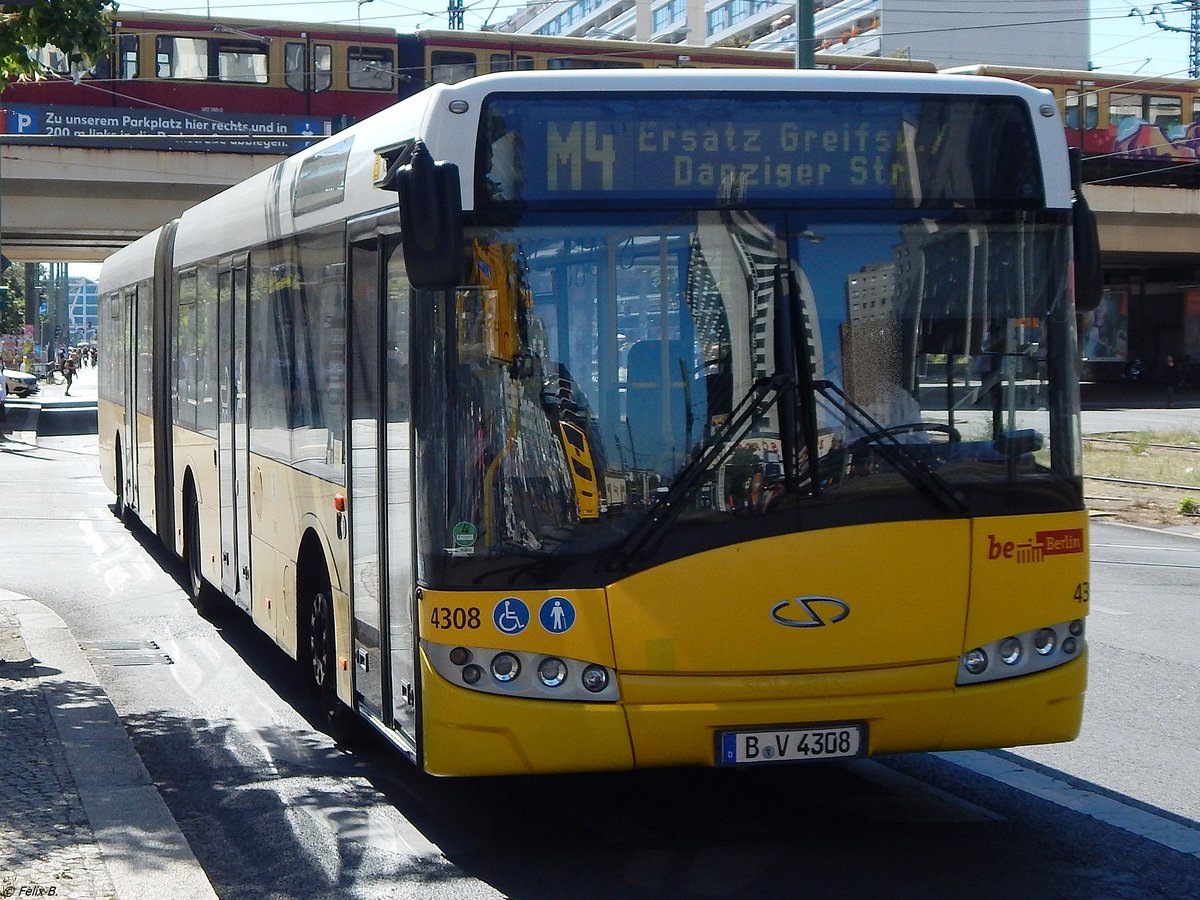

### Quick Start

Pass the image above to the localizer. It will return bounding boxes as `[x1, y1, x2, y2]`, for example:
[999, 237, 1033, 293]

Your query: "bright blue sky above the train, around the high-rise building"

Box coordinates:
[105, 0, 1190, 77]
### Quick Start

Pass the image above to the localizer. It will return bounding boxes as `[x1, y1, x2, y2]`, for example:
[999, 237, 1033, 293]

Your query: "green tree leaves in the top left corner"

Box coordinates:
[0, 0, 116, 91]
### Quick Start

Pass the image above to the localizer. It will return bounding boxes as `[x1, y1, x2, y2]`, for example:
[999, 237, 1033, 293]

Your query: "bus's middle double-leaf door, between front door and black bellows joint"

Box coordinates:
[217, 257, 251, 610]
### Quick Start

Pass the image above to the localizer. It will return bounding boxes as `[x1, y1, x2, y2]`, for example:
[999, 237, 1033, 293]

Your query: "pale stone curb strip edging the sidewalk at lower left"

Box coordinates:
[0, 589, 216, 900]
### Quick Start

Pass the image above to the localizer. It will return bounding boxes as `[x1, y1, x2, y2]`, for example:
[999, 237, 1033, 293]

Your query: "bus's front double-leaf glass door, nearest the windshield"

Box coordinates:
[347, 224, 416, 750]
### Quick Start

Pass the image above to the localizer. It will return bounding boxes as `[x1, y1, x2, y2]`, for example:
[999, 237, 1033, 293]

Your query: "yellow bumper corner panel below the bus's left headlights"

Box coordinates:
[420, 653, 634, 775]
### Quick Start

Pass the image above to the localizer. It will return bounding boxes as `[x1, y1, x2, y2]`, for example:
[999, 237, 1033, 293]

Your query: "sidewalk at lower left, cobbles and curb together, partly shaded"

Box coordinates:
[0, 589, 216, 900]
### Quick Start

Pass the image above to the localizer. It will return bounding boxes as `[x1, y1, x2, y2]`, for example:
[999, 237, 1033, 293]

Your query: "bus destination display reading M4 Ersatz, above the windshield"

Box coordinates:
[482, 95, 1040, 208]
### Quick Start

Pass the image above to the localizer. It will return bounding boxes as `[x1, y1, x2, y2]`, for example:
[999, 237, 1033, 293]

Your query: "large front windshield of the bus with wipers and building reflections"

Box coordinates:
[422, 209, 1081, 584]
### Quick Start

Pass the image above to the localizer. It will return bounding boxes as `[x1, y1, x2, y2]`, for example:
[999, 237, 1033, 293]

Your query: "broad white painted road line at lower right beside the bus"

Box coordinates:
[934, 750, 1200, 859]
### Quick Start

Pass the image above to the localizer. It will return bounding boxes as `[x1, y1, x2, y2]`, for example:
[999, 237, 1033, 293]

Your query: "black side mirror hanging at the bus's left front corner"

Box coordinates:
[395, 142, 463, 290]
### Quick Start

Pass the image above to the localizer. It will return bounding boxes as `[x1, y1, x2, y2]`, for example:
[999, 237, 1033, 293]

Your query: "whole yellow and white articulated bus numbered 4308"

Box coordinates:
[100, 71, 1098, 775]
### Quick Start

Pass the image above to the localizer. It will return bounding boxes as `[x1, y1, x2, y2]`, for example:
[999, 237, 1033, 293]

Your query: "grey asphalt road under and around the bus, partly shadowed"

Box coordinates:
[0, 438, 1200, 900]
